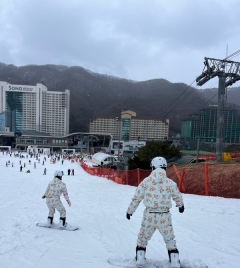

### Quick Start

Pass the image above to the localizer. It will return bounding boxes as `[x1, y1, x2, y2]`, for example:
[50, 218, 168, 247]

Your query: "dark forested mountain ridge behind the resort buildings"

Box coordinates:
[0, 63, 240, 135]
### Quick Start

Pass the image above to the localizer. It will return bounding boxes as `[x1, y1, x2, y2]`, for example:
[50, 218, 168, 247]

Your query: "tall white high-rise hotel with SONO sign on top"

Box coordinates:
[0, 81, 70, 136]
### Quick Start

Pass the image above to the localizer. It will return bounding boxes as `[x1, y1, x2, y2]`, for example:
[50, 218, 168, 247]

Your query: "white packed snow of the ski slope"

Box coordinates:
[0, 152, 240, 268]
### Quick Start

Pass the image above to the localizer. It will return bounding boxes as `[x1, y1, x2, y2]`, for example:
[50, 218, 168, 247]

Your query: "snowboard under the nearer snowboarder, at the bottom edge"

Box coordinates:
[108, 258, 208, 268]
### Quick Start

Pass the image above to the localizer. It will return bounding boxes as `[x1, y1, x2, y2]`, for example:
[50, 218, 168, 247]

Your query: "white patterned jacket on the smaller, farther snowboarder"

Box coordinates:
[44, 177, 69, 201]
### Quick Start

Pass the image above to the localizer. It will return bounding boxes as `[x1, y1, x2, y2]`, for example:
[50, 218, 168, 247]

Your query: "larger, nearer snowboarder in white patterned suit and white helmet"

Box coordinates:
[126, 157, 184, 268]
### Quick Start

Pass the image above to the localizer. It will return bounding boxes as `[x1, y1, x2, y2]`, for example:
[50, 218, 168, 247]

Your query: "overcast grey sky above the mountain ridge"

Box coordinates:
[0, 0, 240, 87]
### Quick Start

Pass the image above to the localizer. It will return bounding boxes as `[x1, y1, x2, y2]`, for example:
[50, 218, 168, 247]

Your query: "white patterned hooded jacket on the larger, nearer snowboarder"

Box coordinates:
[127, 168, 183, 214]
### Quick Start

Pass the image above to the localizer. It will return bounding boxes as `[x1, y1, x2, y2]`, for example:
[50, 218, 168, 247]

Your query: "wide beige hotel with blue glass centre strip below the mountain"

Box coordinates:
[89, 110, 169, 141]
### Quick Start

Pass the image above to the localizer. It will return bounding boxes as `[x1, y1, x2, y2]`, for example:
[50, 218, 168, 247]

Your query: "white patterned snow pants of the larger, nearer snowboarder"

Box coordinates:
[137, 209, 177, 250]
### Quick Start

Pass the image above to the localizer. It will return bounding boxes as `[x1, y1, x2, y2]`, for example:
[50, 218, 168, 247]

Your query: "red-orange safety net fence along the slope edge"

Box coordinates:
[80, 159, 240, 198]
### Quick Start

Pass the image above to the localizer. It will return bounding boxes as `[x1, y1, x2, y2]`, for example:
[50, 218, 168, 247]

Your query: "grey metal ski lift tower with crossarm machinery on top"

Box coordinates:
[196, 57, 240, 162]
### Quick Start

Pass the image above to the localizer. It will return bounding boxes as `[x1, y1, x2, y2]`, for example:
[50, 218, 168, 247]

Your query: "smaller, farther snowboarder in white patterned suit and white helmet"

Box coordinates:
[42, 171, 71, 226]
